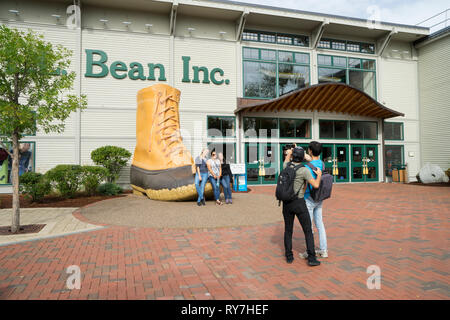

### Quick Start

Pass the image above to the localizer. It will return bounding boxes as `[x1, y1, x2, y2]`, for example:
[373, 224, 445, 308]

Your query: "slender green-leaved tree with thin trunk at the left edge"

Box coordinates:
[0, 25, 87, 233]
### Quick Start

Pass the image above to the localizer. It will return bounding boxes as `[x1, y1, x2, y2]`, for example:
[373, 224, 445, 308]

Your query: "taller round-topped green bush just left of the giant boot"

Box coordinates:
[91, 146, 131, 182]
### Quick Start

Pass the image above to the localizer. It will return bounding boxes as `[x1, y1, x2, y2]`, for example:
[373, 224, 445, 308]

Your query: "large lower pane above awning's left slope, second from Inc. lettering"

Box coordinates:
[278, 63, 309, 96]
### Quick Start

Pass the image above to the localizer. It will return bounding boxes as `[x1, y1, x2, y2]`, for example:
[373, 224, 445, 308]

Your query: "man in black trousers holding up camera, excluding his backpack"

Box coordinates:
[283, 147, 322, 266]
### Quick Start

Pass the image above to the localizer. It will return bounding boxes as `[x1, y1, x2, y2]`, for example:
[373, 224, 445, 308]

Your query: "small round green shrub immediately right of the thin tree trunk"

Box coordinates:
[19, 172, 52, 202]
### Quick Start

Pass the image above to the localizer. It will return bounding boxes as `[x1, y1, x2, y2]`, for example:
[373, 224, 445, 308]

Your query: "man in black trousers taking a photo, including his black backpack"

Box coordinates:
[276, 147, 322, 266]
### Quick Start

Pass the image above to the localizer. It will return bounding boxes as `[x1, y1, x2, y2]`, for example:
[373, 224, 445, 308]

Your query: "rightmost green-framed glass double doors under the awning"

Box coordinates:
[352, 144, 378, 182]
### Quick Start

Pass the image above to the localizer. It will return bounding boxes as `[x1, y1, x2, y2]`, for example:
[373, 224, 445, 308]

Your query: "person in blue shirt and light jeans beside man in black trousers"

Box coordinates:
[300, 141, 328, 259]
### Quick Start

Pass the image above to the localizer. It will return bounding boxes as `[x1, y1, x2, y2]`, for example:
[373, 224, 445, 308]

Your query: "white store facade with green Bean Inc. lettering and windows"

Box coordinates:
[0, 0, 450, 192]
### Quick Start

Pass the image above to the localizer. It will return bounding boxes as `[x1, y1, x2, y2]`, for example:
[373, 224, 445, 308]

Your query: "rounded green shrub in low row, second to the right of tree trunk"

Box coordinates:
[46, 164, 83, 198]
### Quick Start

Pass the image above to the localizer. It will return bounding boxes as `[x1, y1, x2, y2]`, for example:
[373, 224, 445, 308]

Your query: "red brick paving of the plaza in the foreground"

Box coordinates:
[0, 183, 450, 299]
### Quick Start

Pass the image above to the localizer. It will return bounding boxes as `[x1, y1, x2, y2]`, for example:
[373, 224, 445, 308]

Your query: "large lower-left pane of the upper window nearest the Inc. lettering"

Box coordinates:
[244, 61, 277, 98]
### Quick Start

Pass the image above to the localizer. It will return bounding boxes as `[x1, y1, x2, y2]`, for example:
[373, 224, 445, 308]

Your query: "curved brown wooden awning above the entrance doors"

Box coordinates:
[234, 83, 404, 119]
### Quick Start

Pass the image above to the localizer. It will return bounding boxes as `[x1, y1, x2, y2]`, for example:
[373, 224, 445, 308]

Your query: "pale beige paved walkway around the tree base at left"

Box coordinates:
[0, 208, 101, 246]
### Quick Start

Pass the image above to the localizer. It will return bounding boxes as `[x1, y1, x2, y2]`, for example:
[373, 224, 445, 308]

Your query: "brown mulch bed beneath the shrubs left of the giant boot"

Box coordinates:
[0, 190, 131, 209]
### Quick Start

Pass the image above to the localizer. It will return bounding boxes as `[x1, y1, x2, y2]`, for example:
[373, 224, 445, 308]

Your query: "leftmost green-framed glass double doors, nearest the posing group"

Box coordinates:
[245, 142, 278, 184]
